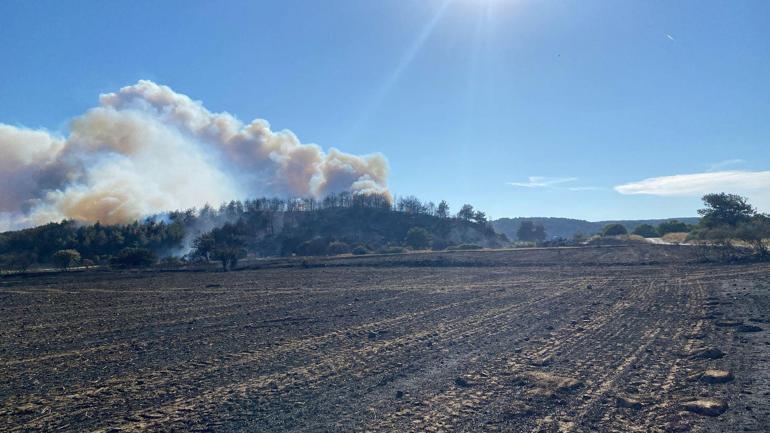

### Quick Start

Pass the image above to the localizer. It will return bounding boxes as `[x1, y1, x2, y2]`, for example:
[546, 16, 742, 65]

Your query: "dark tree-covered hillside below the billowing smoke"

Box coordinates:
[0, 193, 508, 270]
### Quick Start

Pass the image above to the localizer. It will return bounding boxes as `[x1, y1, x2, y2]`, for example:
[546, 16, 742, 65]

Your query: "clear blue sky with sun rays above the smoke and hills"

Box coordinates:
[0, 0, 770, 220]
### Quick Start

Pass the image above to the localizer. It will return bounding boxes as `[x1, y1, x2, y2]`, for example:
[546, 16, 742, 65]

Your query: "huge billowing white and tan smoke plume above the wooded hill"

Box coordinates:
[0, 81, 388, 231]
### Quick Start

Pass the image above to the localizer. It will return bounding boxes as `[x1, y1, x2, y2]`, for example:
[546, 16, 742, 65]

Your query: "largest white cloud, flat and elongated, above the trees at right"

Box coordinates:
[615, 170, 770, 211]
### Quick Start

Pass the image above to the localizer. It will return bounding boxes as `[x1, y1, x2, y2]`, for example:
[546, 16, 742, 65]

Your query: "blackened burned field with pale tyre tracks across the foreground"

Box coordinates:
[0, 246, 770, 432]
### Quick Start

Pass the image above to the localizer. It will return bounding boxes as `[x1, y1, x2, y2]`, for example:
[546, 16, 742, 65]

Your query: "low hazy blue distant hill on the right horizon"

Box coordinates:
[492, 217, 698, 240]
